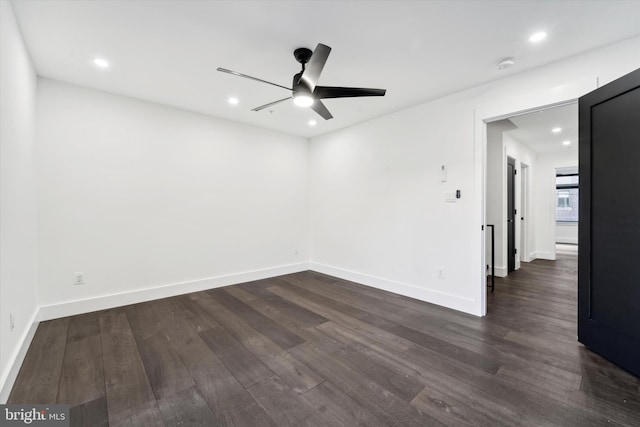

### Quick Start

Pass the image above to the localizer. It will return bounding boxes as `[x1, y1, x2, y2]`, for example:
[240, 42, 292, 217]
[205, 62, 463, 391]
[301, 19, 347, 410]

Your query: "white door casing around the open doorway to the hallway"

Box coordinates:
[472, 76, 598, 316]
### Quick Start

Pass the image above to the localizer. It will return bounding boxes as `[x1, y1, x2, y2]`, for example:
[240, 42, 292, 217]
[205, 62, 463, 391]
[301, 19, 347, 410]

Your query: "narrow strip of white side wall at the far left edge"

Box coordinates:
[0, 1, 38, 403]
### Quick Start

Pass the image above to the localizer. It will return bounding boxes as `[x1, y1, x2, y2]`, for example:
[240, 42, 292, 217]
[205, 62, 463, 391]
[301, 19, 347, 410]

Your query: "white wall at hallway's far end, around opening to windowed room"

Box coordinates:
[534, 150, 578, 260]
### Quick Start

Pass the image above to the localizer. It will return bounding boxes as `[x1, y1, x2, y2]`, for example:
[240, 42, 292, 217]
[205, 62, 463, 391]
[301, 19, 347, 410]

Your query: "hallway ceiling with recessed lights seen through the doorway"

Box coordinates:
[505, 103, 578, 156]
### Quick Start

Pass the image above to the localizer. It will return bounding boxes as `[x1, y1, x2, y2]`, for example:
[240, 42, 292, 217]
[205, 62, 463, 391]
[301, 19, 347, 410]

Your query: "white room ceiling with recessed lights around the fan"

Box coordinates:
[12, 0, 640, 137]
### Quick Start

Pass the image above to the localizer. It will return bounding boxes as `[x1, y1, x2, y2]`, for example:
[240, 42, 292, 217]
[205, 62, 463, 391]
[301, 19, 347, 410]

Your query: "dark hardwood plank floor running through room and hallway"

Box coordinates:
[9, 249, 640, 427]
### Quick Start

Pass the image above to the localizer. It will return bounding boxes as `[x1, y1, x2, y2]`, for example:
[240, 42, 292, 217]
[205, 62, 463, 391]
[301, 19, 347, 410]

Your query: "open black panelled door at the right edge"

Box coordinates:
[578, 69, 640, 376]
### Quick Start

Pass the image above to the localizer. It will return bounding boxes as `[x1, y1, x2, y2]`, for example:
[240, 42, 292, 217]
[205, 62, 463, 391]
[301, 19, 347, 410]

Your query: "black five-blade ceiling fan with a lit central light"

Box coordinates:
[218, 43, 387, 120]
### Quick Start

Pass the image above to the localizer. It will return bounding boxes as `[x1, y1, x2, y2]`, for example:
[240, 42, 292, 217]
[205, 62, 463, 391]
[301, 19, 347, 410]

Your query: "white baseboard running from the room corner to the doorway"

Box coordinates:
[309, 262, 481, 316]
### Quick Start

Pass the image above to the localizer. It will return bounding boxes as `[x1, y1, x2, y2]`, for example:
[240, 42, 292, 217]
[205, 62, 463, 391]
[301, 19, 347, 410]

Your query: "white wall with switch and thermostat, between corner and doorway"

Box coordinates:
[311, 93, 480, 311]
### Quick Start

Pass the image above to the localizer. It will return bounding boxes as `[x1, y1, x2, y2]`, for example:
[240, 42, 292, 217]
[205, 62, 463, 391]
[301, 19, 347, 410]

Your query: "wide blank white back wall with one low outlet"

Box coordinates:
[38, 80, 309, 318]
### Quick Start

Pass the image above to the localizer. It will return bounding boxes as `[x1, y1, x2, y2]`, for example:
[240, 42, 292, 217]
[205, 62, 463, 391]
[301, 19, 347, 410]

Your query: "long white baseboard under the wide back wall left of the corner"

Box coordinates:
[38, 262, 309, 321]
